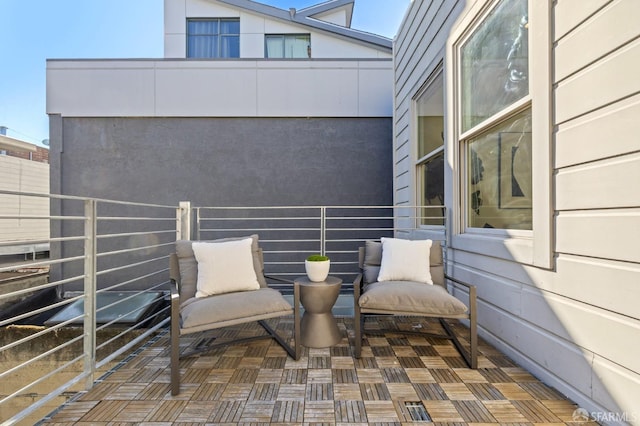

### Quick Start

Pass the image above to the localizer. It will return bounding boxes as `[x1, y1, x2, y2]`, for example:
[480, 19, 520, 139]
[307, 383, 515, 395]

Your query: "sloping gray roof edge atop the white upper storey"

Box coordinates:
[217, 0, 393, 50]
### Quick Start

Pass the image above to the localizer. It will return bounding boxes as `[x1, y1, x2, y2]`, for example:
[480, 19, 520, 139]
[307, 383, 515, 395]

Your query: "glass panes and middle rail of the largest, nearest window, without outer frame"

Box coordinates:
[459, 0, 533, 230]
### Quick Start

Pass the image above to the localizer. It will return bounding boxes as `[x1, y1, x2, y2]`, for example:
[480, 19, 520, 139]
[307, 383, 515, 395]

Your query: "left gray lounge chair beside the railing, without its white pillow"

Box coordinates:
[170, 235, 300, 395]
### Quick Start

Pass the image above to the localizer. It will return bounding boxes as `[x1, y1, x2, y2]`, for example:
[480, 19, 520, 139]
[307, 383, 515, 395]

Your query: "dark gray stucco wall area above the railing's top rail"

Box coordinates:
[51, 118, 393, 206]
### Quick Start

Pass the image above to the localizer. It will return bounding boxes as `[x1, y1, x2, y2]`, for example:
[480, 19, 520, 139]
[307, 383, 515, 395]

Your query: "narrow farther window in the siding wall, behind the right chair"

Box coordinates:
[415, 69, 444, 225]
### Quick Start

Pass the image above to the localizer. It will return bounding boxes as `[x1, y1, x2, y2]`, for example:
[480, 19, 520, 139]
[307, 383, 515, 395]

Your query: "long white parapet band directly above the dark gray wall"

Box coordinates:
[47, 59, 393, 117]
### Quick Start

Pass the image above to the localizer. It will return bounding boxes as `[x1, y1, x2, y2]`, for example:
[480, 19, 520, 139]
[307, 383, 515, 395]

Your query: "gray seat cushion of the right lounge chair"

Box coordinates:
[358, 281, 467, 318]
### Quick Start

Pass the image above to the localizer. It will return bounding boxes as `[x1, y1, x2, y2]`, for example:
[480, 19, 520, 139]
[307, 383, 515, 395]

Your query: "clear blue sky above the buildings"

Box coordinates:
[0, 0, 411, 144]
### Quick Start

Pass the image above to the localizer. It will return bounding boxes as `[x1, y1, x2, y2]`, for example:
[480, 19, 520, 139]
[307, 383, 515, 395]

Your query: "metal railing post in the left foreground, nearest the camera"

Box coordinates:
[83, 200, 98, 390]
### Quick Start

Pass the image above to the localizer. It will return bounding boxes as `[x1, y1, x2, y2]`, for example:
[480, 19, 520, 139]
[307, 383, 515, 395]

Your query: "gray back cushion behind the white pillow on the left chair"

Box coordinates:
[176, 235, 267, 303]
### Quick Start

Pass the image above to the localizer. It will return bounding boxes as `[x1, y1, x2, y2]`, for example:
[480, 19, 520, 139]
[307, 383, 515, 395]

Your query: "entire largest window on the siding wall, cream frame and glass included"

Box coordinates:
[445, 0, 553, 268]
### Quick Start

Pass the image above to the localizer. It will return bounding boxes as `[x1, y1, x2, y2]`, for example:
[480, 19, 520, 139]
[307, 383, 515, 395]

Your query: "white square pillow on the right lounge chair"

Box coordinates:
[378, 237, 433, 284]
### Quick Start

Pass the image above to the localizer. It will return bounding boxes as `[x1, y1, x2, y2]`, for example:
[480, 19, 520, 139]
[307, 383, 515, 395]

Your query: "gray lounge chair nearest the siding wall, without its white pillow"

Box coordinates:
[353, 241, 478, 368]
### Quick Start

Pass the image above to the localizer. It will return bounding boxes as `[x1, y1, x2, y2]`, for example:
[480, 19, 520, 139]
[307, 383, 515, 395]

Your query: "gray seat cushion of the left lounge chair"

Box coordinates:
[180, 288, 293, 332]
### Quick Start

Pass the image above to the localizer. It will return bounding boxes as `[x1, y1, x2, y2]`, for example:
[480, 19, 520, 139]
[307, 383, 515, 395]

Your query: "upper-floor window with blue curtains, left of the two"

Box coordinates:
[187, 18, 240, 58]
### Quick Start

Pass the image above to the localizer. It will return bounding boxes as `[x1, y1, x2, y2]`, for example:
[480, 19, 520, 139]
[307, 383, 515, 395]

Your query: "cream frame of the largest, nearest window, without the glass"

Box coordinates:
[445, 0, 554, 269]
